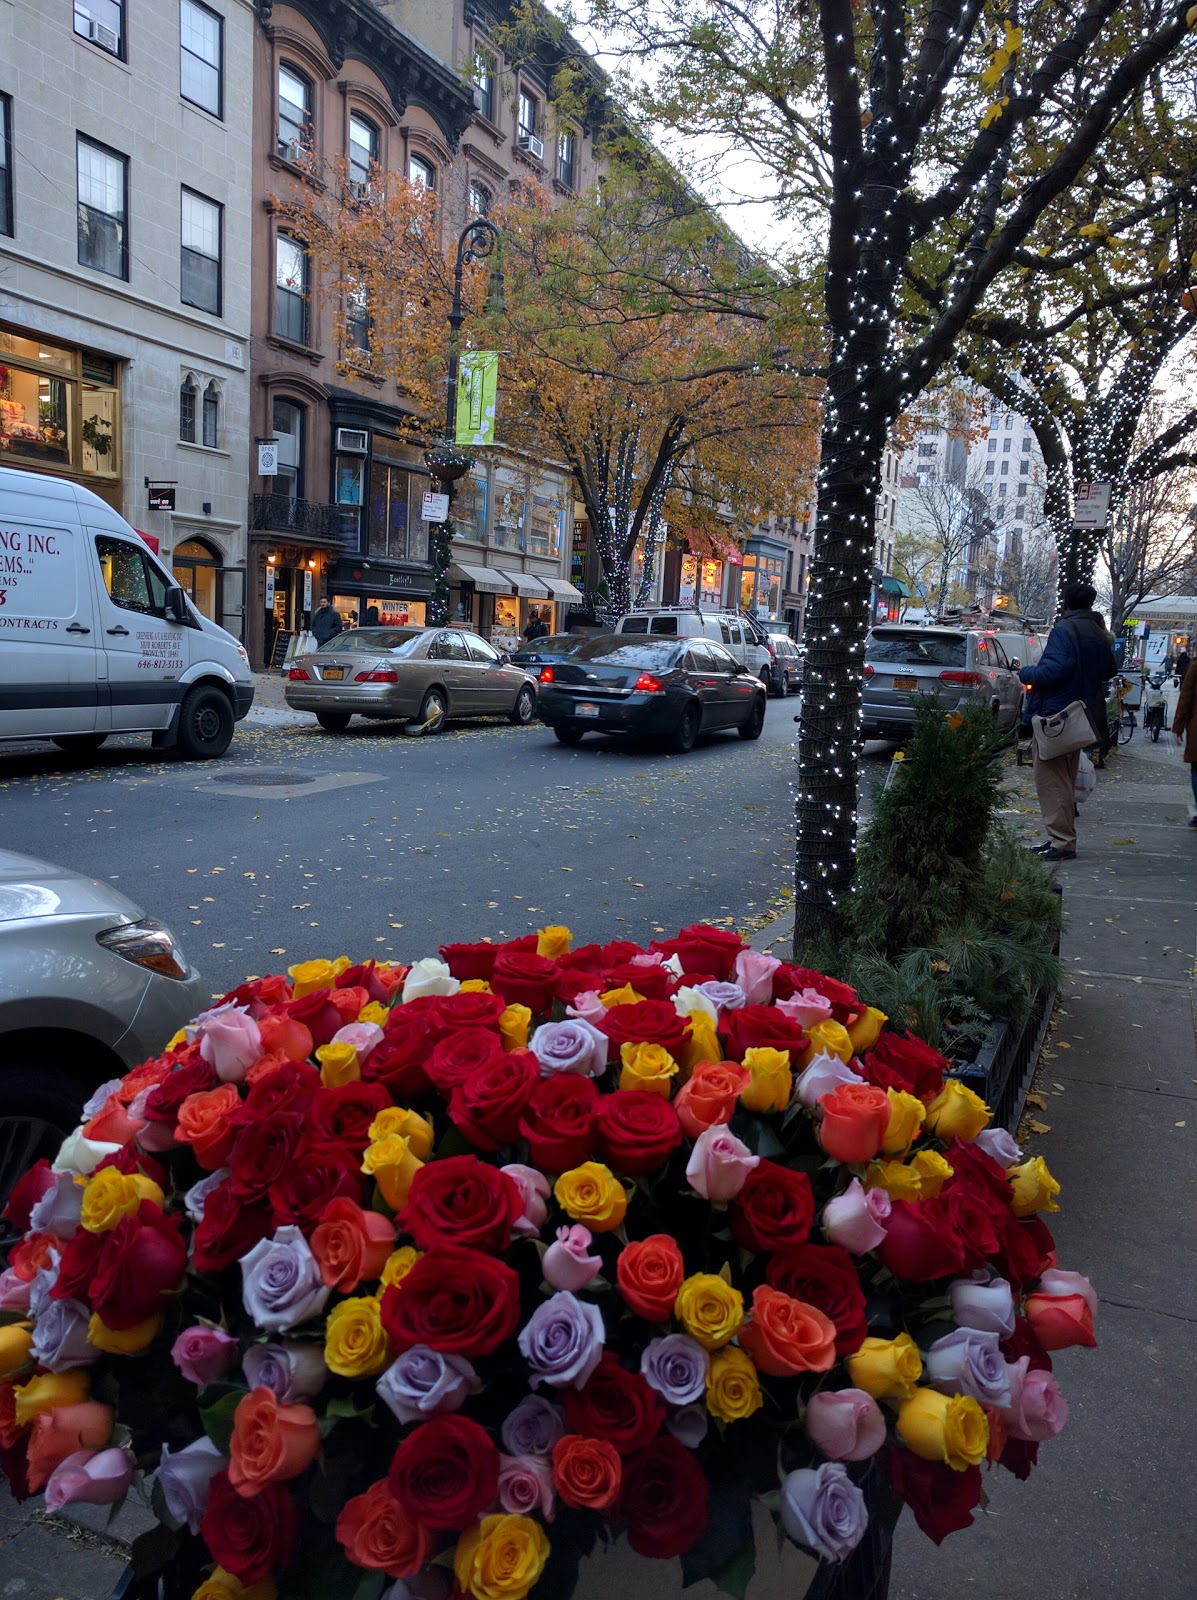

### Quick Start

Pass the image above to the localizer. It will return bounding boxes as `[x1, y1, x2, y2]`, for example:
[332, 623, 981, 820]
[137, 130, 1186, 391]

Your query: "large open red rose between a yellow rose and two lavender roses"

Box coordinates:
[382, 1241, 520, 1360]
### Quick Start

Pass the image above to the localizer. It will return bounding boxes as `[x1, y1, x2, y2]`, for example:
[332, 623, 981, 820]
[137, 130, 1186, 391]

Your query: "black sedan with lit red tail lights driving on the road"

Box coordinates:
[536, 634, 765, 750]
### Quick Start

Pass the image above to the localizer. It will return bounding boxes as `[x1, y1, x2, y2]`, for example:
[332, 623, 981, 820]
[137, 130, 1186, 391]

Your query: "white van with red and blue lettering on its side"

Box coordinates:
[0, 467, 253, 760]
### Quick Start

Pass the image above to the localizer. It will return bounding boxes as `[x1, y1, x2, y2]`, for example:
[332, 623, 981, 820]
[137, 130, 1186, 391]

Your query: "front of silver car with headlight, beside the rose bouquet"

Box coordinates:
[0, 850, 210, 1210]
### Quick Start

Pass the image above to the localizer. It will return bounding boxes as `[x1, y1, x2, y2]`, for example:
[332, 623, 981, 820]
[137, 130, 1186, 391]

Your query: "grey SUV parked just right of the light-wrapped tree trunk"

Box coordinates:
[861, 622, 1023, 739]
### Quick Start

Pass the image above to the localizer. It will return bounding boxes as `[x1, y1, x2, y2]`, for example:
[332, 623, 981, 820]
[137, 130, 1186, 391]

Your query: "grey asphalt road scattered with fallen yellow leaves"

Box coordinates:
[0, 699, 888, 994]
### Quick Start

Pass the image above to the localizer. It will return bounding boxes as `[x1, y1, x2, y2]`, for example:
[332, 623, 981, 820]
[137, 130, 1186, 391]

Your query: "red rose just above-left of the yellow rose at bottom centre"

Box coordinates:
[389, 1416, 499, 1533]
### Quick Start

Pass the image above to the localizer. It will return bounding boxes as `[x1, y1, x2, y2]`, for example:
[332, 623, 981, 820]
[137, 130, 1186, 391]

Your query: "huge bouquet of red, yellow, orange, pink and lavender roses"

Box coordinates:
[0, 926, 1095, 1600]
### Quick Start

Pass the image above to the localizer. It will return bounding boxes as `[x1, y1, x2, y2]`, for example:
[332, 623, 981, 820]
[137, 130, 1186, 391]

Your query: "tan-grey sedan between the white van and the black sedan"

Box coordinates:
[285, 627, 536, 733]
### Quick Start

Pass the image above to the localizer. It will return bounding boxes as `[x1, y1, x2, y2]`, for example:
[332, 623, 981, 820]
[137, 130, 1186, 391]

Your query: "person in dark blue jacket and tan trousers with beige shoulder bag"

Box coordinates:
[1023, 582, 1115, 861]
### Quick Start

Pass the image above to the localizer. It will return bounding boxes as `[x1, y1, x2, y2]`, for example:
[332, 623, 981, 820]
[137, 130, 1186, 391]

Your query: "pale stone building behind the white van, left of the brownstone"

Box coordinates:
[0, 0, 254, 637]
